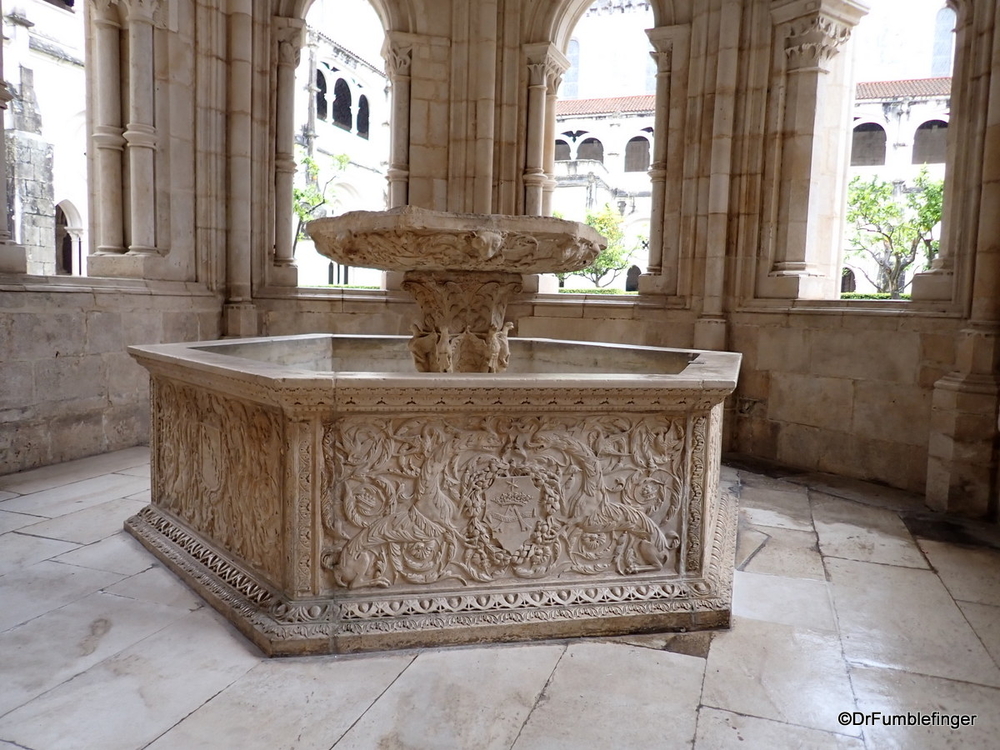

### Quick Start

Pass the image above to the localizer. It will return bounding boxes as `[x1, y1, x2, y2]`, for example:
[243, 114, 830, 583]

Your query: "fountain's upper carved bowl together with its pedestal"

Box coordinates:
[308, 206, 607, 372]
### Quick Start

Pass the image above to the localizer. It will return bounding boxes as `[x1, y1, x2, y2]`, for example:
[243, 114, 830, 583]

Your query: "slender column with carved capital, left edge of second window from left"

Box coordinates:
[272, 17, 305, 286]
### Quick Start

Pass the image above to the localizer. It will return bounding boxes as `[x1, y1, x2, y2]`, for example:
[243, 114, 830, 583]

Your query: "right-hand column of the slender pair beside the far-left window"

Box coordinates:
[123, 0, 159, 255]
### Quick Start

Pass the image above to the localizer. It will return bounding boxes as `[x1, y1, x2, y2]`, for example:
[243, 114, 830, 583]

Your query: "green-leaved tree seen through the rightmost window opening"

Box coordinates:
[847, 168, 944, 299]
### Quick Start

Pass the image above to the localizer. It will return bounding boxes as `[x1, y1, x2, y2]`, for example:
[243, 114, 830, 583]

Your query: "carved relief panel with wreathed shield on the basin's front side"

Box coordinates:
[322, 415, 687, 588]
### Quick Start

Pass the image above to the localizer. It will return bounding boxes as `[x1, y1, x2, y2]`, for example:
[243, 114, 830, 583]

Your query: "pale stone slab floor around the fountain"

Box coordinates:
[0, 448, 1000, 750]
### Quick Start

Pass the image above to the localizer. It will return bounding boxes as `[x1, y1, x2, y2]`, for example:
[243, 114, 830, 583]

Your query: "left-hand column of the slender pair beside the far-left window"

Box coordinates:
[91, 0, 125, 255]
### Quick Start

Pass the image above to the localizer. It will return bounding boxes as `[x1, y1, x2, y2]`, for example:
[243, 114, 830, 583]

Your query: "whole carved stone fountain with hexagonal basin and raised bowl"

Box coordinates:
[126, 208, 740, 655]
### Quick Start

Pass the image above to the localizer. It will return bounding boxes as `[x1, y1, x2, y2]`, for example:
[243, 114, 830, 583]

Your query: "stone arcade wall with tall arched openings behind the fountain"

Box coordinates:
[0, 0, 1000, 518]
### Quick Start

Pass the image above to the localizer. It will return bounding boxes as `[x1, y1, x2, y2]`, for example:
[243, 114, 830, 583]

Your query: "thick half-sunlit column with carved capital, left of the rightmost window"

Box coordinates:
[759, 0, 867, 299]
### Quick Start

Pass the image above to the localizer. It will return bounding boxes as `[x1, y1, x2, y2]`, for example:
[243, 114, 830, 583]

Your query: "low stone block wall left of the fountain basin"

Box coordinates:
[0, 277, 220, 474]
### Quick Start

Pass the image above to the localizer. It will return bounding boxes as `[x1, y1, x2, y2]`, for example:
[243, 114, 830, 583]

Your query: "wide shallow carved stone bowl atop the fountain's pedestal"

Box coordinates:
[307, 206, 607, 273]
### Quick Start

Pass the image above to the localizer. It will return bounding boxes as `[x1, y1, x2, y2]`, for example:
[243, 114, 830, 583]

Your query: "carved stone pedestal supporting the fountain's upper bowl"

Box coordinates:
[402, 271, 521, 372]
